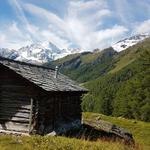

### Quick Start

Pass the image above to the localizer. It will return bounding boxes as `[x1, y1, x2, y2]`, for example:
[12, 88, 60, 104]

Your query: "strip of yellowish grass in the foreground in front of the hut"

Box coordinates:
[0, 136, 133, 150]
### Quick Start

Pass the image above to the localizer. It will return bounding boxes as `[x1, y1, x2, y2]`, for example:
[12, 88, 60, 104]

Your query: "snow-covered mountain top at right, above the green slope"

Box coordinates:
[112, 33, 150, 52]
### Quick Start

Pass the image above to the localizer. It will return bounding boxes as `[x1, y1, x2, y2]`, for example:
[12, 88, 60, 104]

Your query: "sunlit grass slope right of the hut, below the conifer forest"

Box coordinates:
[83, 112, 150, 150]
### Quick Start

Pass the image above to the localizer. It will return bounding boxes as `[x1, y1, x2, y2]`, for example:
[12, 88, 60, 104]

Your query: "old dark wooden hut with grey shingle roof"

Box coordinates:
[0, 57, 87, 134]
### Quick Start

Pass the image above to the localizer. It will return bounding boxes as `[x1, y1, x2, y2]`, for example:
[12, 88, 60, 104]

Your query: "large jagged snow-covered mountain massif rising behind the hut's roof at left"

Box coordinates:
[0, 41, 84, 64]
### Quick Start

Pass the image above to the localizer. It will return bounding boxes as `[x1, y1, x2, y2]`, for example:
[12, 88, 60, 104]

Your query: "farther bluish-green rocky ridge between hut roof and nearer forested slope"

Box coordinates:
[48, 47, 117, 83]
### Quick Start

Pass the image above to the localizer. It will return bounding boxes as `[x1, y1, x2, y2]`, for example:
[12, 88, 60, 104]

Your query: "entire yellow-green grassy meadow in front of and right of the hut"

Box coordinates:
[0, 113, 150, 150]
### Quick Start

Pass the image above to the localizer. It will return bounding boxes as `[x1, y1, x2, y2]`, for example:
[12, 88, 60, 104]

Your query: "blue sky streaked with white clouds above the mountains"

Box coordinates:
[0, 0, 150, 50]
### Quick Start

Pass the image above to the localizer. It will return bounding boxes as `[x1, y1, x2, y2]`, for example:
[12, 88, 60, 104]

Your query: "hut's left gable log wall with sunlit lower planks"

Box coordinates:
[0, 66, 37, 132]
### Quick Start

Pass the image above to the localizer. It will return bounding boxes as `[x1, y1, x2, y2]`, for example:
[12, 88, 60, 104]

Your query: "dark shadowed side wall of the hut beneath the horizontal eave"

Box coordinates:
[39, 92, 81, 133]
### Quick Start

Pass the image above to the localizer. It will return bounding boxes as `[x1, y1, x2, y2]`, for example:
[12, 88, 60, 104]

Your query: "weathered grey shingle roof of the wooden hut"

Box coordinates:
[0, 57, 87, 92]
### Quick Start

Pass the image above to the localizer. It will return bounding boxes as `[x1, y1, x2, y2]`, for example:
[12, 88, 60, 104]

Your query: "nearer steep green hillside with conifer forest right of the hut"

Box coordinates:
[82, 39, 150, 121]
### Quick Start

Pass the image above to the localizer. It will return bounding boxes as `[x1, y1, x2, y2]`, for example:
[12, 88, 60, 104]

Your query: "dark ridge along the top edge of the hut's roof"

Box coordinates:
[0, 56, 55, 70]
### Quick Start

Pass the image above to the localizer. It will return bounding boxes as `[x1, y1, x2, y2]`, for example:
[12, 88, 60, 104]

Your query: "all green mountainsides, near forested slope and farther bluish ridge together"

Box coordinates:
[47, 39, 150, 121]
